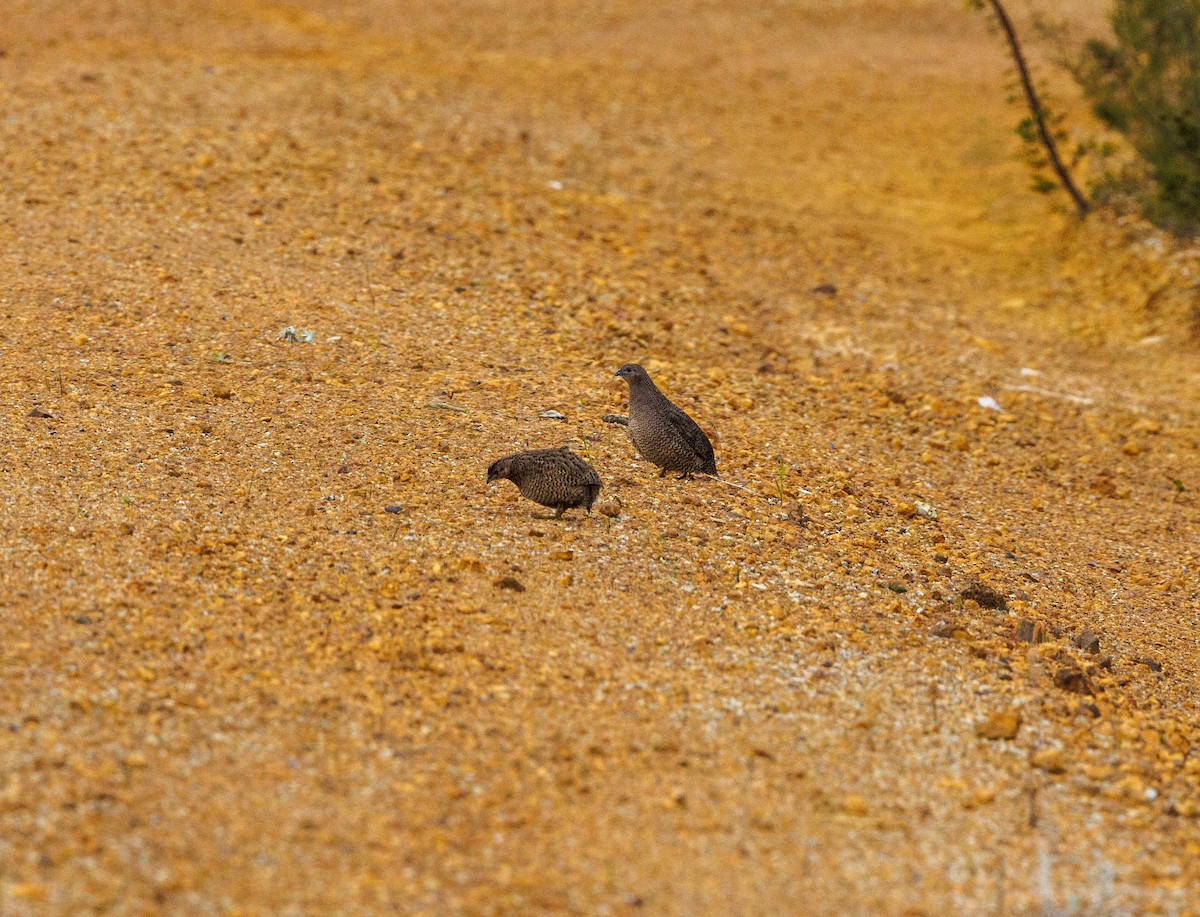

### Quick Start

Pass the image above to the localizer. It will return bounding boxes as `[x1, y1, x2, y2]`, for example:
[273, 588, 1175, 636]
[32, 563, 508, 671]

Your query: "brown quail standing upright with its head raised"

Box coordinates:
[617, 362, 716, 478]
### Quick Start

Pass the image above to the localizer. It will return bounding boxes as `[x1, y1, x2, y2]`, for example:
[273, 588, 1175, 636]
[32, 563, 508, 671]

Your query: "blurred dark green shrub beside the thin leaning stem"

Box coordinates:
[1073, 0, 1200, 233]
